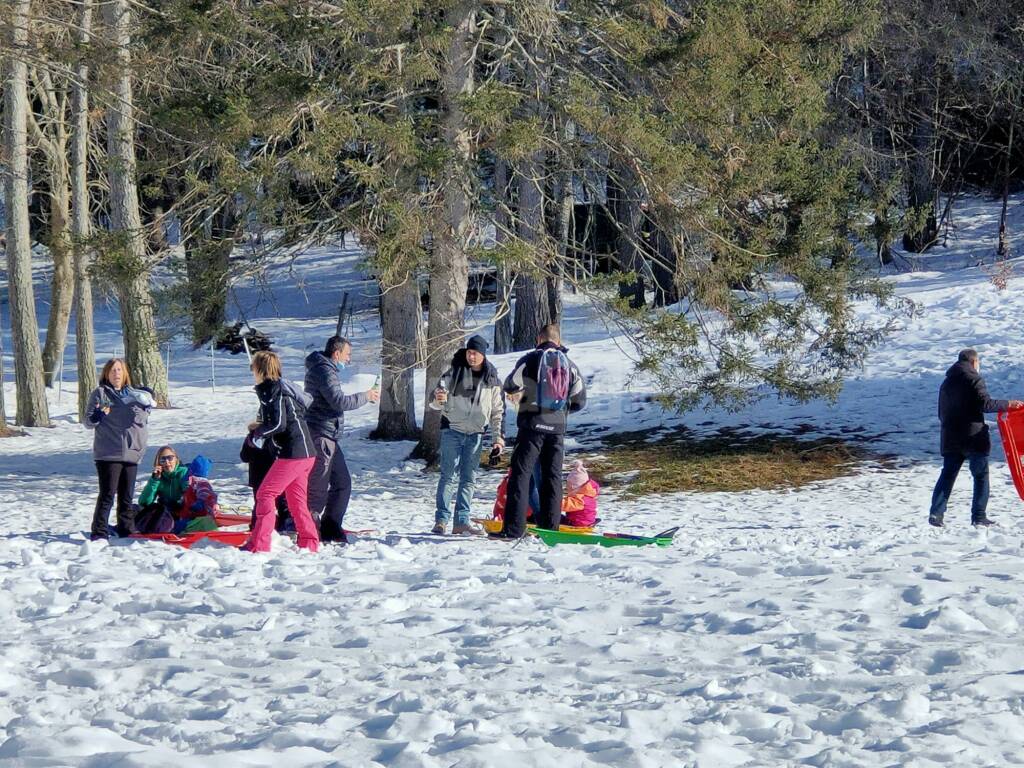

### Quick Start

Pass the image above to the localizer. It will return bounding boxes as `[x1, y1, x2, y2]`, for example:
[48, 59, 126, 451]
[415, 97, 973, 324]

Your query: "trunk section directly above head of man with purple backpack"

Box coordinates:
[512, 166, 551, 350]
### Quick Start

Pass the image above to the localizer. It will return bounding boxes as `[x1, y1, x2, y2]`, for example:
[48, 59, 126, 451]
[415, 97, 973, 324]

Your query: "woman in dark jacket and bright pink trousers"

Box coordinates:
[244, 352, 319, 552]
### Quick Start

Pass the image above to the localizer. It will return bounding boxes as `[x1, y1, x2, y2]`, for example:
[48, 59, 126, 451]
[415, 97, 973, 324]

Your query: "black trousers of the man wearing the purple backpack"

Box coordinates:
[504, 429, 565, 538]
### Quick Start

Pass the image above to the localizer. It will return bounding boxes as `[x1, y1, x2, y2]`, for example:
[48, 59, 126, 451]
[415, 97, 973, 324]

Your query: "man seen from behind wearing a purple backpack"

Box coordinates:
[495, 325, 587, 539]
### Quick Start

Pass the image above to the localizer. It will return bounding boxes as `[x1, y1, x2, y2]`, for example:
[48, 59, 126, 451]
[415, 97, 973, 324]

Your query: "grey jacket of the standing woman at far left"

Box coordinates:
[85, 384, 156, 464]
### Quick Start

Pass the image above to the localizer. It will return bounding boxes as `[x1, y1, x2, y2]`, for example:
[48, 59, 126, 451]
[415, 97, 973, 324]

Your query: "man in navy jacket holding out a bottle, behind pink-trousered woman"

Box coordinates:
[304, 336, 380, 544]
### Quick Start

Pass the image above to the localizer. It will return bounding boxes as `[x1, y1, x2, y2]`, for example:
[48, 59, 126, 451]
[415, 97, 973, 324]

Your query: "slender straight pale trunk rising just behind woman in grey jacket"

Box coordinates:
[71, 0, 96, 421]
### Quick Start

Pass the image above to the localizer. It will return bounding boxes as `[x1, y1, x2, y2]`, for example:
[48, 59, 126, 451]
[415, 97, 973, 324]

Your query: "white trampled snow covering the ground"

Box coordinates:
[0, 201, 1024, 768]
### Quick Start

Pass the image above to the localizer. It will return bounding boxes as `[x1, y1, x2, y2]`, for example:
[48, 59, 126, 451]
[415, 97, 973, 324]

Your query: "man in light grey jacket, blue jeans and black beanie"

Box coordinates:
[430, 335, 505, 536]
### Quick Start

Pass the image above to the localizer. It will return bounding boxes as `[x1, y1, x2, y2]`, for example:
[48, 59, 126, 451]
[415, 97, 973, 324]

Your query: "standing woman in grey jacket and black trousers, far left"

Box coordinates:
[85, 357, 155, 541]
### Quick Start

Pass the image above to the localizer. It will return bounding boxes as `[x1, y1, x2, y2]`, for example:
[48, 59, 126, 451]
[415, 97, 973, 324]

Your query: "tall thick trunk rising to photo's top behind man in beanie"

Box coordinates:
[413, 2, 476, 465]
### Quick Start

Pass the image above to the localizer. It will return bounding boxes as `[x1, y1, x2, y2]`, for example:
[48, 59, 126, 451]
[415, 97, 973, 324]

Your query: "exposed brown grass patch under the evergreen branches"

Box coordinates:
[566, 430, 885, 497]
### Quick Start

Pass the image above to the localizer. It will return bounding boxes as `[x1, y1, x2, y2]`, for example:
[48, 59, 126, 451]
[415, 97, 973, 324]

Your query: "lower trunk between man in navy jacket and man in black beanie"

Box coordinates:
[370, 275, 421, 440]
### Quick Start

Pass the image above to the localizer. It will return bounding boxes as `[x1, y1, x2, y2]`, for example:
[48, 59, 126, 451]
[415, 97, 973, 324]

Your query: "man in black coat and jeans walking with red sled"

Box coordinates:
[928, 349, 1024, 526]
